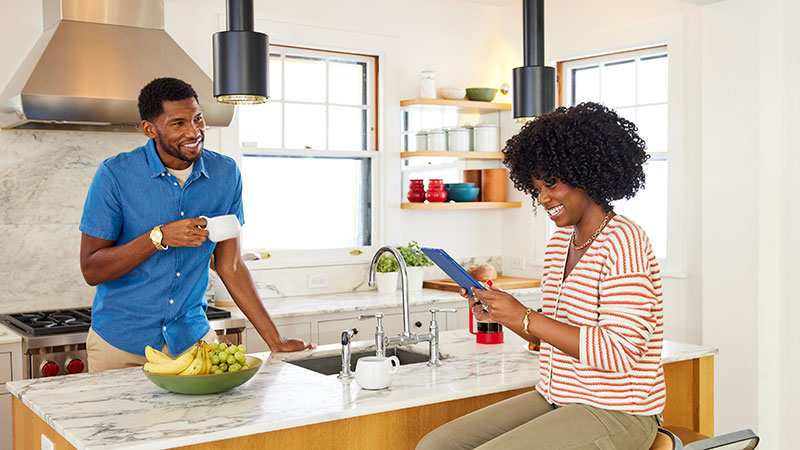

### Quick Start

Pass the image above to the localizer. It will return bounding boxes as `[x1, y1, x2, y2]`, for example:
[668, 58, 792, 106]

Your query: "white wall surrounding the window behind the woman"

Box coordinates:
[498, 0, 702, 343]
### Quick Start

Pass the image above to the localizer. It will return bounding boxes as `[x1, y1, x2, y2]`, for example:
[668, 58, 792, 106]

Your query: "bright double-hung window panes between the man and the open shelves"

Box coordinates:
[237, 45, 377, 252]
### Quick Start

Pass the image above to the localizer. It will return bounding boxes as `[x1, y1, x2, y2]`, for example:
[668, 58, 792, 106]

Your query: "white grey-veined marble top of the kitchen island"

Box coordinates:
[6, 330, 716, 449]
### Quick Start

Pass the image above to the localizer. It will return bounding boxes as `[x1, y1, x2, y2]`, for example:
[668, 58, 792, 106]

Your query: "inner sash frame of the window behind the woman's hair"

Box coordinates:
[556, 44, 687, 272]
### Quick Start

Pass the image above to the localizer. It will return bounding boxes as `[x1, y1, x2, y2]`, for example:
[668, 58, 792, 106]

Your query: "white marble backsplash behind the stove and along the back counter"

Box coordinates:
[0, 130, 502, 314]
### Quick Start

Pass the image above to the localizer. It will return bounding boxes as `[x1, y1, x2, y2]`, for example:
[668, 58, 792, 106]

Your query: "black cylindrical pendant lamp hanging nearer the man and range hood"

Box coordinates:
[214, 0, 269, 105]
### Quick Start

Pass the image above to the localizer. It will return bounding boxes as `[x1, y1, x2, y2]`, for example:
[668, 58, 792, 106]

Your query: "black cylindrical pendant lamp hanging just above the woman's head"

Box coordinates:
[512, 0, 556, 122]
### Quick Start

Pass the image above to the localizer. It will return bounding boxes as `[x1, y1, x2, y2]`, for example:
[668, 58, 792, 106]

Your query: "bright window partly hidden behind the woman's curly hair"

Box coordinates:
[558, 46, 669, 259]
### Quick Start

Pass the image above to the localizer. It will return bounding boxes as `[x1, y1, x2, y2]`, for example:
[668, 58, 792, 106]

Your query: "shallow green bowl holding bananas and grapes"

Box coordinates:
[142, 356, 264, 394]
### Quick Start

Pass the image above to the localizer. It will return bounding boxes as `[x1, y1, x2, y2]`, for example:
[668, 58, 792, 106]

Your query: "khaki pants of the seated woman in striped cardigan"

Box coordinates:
[417, 390, 658, 450]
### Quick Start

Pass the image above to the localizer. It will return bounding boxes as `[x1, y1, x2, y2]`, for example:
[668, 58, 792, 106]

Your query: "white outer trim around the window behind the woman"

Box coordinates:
[534, 34, 689, 278]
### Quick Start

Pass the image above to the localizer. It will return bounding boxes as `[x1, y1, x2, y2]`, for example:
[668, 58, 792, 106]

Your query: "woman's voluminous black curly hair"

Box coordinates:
[503, 102, 650, 211]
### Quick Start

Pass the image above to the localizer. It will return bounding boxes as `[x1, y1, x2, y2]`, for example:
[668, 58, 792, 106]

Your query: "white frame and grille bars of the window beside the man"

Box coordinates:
[223, 44, 383, 269]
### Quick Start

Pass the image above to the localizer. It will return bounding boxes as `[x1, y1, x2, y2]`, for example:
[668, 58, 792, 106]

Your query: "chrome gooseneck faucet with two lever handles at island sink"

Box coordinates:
[358, 246, 456, 366]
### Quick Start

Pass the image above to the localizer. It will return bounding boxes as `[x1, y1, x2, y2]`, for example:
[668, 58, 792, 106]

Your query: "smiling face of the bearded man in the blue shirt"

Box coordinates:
[144, 97, 206, 169]
